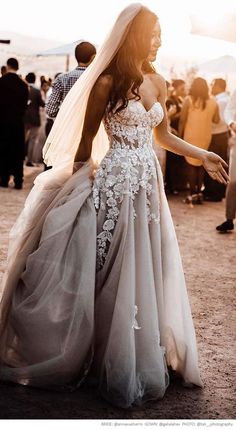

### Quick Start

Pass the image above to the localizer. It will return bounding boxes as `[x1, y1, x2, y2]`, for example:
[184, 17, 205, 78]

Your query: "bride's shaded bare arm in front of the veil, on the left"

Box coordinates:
[74, 75, 112, 164]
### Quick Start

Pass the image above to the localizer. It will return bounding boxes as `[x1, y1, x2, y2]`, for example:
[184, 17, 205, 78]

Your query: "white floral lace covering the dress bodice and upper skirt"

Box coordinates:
[93, 102, 163, 270]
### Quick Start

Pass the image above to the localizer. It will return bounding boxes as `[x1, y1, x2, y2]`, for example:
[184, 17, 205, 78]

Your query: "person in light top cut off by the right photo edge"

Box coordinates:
[216, 90, 236, 232]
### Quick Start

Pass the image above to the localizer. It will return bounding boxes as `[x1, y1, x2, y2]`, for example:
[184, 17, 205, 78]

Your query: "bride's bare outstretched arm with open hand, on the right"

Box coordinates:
[153, 75, 229, 184]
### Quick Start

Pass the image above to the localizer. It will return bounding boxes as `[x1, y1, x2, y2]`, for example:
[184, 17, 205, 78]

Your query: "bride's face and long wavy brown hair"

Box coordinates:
[103, 7, 158, 112]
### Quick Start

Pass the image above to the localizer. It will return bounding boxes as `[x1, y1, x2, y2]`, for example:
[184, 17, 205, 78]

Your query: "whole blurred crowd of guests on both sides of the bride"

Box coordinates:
[0, 42, 236, 232]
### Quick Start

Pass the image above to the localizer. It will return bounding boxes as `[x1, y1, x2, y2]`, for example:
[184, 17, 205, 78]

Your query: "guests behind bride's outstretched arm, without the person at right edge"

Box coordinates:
[156, 77, 231, 204]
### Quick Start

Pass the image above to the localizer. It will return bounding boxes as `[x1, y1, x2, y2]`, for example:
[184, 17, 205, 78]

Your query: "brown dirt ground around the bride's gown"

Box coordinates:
[0, 167, 236, 419]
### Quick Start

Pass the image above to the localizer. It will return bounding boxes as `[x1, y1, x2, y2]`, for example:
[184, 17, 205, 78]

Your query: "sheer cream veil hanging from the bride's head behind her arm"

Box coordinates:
[43, 3, 142, 167]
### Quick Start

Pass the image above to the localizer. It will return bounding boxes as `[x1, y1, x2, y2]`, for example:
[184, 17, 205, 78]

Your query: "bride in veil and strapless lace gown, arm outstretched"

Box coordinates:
[0, 4, 228, 407]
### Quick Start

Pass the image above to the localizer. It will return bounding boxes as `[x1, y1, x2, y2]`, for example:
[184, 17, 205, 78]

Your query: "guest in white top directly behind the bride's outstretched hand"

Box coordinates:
[203, 78, 229, 202]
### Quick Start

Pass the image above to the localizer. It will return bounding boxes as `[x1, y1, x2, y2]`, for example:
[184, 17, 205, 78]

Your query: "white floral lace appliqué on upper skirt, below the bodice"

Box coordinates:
[93, 148, 160, 270]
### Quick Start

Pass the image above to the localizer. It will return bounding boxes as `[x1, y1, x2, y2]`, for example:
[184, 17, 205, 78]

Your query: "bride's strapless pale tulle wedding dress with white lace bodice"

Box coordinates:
[0, 100, 201, 407]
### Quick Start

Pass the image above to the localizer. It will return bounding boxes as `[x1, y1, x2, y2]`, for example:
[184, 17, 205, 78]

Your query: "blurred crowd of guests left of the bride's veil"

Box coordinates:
[0, 42, 96, 189]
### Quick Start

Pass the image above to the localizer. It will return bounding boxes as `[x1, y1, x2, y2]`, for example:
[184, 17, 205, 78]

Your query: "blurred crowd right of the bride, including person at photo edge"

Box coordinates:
[155, 77, 236, 232]
